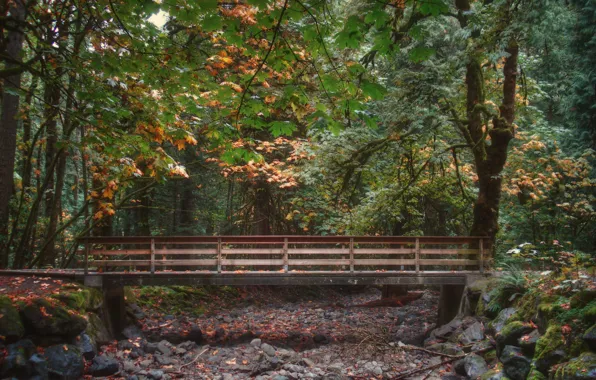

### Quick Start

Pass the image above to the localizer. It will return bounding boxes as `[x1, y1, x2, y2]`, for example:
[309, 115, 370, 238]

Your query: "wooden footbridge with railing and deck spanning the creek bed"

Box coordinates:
[81, 235, 490, 287]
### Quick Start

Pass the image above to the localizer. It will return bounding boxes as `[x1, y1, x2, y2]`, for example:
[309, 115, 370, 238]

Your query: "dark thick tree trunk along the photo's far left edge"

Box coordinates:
[0, 0, 26, 268]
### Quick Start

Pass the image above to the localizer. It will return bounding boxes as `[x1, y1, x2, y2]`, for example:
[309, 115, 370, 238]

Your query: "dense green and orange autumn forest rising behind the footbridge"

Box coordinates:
[0, 0, 596, 268]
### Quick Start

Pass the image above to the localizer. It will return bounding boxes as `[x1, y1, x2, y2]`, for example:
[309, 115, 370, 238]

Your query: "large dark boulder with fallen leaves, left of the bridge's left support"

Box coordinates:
[21, 298, 87, 338]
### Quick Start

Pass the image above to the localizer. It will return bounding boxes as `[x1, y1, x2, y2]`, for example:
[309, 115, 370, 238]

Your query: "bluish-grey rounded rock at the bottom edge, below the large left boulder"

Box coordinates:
[44, 344, 84, 380]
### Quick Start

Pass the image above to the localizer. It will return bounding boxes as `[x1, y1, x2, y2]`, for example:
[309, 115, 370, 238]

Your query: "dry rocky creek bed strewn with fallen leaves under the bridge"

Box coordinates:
[113, 288, 447, 380]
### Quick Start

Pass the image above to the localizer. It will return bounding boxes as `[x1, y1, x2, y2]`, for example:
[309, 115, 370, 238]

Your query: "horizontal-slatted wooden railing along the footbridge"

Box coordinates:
[80, 235, 490, 273]
